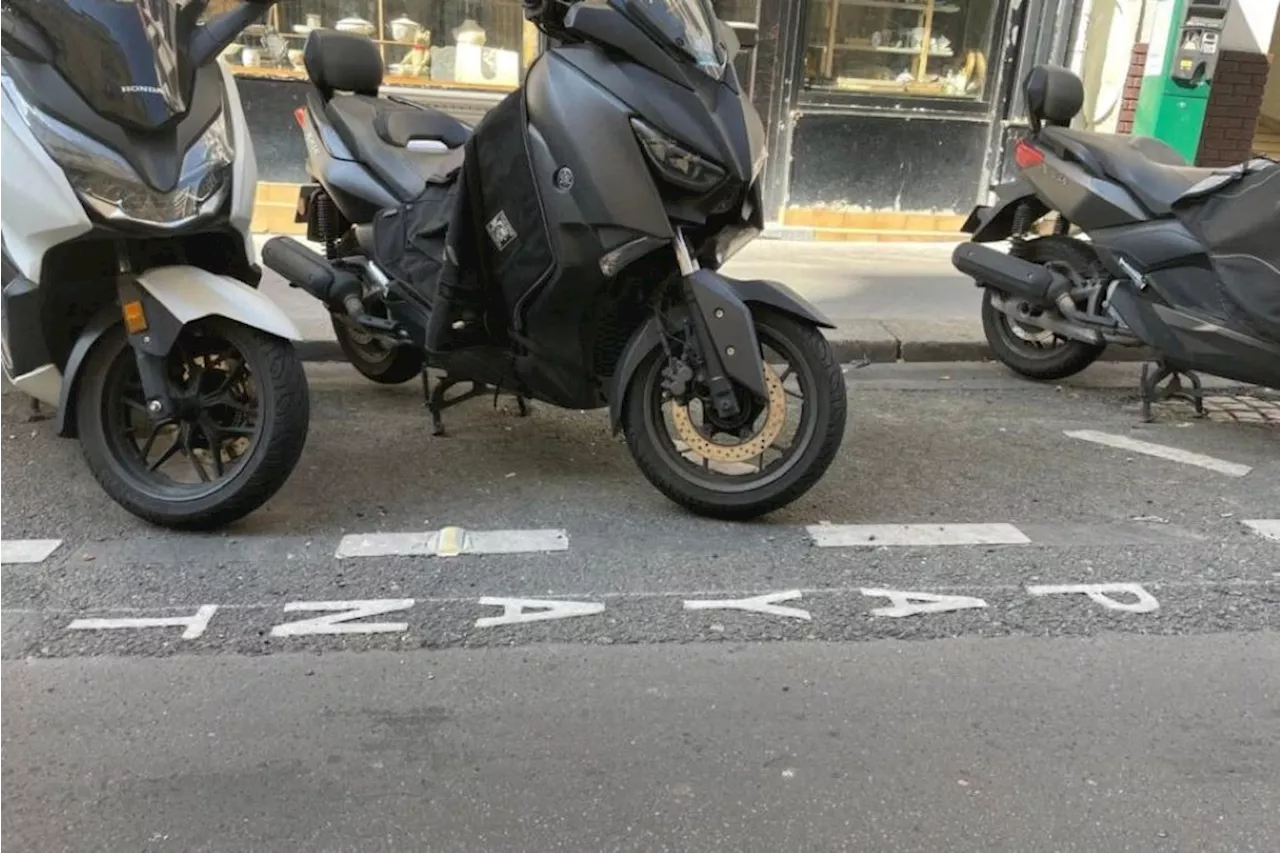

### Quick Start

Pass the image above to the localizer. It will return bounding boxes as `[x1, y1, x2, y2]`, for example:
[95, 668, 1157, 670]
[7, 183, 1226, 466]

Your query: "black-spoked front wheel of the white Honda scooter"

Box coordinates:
[77, 319, 310, 530]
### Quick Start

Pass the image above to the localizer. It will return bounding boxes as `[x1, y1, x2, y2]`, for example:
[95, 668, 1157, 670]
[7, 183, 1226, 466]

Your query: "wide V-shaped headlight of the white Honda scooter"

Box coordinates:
[0, 77, 234, 225]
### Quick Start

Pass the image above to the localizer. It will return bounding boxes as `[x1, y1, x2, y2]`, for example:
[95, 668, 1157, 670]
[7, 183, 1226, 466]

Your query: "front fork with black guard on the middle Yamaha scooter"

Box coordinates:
[673, 229, 768, 420]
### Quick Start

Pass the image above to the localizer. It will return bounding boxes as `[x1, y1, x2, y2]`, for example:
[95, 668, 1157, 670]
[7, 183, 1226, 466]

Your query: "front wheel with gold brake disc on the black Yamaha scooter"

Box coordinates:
[623, 310, 846, 521]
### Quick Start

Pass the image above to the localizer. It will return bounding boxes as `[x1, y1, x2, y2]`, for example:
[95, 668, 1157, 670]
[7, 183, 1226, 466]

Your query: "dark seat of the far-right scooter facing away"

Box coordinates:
[1041, 126, 1216, 216]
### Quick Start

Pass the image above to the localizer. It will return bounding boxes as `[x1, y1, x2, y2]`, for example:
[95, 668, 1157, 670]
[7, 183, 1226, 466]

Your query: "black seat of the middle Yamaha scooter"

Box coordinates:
[325, 95, 470, 201]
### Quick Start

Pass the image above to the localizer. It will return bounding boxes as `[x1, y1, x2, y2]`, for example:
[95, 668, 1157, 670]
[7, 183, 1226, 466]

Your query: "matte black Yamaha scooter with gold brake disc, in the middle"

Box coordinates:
[262, 0, 846, 519]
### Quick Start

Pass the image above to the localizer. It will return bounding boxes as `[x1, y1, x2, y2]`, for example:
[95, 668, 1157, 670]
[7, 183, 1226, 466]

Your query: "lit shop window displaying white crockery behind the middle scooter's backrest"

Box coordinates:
[205, 0, 538, 91]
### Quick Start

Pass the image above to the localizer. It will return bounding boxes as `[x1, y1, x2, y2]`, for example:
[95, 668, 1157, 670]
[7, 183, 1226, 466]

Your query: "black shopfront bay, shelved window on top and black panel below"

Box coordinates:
[756, 0, 1075, 234]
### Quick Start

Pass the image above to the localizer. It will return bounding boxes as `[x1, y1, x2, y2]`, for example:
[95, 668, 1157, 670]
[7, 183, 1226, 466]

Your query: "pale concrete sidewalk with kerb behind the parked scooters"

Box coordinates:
[261, 236, 1132, 362]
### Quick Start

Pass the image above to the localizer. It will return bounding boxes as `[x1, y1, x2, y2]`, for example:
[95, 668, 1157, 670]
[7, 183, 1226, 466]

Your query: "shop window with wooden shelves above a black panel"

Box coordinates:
[804, 0, 1000, 100]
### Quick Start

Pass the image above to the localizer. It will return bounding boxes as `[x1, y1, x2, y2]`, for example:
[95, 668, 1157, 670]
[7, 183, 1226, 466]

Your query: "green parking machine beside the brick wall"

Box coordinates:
[1133, 0, 1231, 163]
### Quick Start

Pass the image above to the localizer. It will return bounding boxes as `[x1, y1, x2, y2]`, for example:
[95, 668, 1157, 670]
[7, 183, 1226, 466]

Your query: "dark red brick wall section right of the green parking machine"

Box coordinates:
[1196, 50, 1270, 167]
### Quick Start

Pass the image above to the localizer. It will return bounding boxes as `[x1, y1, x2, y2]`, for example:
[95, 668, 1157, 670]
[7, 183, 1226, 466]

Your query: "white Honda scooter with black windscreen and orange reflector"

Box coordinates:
[0, 0, 310, 529]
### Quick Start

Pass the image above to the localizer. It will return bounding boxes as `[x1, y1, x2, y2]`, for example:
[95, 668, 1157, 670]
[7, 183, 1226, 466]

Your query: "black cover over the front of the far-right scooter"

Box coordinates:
[1174, 160, 1280, 341]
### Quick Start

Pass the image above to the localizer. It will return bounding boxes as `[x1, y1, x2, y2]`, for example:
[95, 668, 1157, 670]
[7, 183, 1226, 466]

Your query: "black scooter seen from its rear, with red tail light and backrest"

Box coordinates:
[952, 65, 1280, 420]
